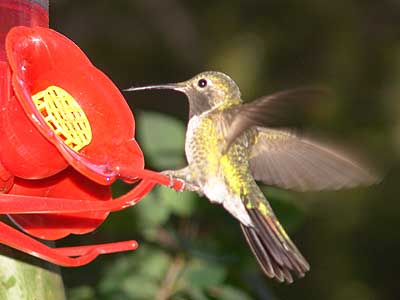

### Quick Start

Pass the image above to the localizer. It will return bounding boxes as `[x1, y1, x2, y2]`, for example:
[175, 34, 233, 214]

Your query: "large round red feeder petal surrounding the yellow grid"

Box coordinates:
[6, 26, 144, 185]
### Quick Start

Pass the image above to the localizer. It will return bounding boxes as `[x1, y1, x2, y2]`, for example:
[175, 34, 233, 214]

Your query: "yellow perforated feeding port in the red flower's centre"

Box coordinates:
[32, 85, 92, 152]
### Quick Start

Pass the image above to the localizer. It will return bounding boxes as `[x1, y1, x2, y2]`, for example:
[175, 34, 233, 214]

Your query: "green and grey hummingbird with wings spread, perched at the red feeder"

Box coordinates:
[126, 71, 377, 283]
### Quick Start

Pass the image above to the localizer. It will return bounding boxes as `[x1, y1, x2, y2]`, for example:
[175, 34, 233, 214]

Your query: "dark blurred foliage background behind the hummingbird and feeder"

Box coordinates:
[50, 0, 400, 300]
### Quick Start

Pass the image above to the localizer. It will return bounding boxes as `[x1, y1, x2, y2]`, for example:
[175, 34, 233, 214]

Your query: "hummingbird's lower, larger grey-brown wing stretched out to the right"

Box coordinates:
[250, 127, 379, 191]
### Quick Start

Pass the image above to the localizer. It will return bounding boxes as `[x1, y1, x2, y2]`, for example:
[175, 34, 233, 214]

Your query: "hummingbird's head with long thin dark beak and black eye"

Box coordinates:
[126, 71, 242, 117]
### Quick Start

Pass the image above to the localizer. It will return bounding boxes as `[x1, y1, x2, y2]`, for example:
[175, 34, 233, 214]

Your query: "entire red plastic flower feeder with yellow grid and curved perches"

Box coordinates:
[0, 26, 181, 266]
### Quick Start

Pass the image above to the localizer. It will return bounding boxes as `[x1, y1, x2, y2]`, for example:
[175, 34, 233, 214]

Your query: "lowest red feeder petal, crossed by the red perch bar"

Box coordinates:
[10, 168, 112, 240]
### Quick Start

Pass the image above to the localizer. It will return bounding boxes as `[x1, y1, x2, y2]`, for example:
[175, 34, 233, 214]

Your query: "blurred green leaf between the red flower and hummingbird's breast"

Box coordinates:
[136, 111, 186, 170]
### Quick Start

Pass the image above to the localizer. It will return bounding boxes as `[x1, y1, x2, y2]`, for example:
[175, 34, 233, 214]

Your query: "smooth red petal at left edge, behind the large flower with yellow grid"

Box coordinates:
[0, 62, 68, 179]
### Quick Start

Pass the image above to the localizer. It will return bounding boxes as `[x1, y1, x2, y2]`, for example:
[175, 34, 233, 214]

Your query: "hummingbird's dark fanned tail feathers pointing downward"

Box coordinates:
[242, 208, 310, 283]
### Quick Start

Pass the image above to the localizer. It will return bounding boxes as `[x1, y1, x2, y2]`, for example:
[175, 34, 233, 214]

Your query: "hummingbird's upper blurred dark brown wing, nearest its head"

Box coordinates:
[225, 88, 328, 151]
